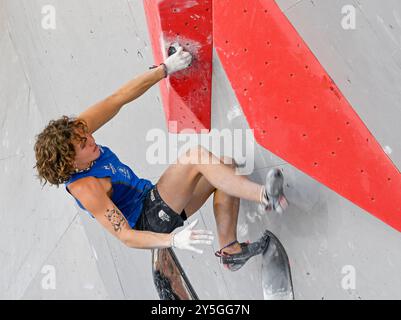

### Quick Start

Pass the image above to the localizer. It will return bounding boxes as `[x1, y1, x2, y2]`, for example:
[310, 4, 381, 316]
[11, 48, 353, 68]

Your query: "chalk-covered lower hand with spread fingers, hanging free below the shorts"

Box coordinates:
[171, 220, 213, 254]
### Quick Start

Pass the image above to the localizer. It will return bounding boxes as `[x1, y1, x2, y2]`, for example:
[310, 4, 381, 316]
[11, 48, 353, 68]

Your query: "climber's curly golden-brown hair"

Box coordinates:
[34, 116, 88, 187]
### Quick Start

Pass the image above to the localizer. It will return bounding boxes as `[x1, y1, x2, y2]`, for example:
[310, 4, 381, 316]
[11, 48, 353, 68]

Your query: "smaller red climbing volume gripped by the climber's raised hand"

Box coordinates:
[144, 0, 213, 133]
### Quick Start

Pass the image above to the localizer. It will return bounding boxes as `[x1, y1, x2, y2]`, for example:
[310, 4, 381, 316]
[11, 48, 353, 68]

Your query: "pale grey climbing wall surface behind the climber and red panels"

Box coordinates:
[0, 0, 401, 299]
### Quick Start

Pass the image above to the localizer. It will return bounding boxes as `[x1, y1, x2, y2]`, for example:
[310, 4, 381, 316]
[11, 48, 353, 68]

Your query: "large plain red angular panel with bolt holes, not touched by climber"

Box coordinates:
[213, 0, 401, 231]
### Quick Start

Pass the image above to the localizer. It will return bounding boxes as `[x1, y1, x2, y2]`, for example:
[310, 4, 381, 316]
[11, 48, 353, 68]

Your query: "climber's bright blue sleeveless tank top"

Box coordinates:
[65, 145, 154, 228]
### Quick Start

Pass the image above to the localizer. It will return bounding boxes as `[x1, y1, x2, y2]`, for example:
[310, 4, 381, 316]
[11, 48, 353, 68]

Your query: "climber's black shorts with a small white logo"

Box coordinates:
[134, 185, 187, 233]
